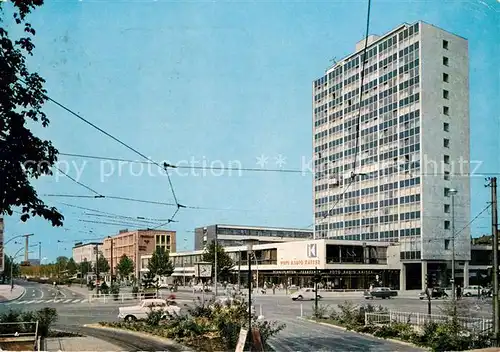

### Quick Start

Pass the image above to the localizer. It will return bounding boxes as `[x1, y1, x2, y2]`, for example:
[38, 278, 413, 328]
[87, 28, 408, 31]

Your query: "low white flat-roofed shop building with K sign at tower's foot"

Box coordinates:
[140, 239, 401, 289]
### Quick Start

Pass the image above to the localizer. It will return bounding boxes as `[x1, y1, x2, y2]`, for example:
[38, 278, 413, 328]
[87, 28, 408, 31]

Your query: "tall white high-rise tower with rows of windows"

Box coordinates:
[313, 22, 470, 286]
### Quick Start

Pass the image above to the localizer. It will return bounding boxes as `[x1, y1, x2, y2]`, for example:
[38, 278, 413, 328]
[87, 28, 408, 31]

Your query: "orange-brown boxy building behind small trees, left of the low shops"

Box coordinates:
[103, 229, 176, 277]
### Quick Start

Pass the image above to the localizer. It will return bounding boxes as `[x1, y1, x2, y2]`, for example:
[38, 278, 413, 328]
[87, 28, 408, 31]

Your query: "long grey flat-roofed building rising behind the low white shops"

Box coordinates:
[194, 224, 313, 250]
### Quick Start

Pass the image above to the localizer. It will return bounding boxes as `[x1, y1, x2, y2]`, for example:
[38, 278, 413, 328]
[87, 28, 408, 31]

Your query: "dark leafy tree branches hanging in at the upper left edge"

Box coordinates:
[0, 0, 64, 226]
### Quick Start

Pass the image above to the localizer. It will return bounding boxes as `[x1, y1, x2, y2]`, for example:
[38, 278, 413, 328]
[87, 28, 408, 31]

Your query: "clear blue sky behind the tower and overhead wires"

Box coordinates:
[1, 0, 500, 259]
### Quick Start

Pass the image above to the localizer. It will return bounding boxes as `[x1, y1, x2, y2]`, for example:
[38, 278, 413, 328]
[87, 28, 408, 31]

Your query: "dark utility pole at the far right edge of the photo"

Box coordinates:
[488, 177, 500, 346]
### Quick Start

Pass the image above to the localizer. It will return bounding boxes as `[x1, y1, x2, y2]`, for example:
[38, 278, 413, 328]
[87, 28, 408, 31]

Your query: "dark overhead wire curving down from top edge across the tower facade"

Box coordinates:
[308, 0, 371, 228]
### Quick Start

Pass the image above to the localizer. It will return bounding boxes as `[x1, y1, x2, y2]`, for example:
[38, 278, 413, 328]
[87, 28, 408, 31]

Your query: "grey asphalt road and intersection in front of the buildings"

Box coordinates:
[0, 282, 491, 352]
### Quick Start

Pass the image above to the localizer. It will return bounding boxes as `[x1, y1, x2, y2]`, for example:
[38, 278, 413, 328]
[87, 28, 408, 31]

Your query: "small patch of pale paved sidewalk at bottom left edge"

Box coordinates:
[45, 336, 123, 351]
